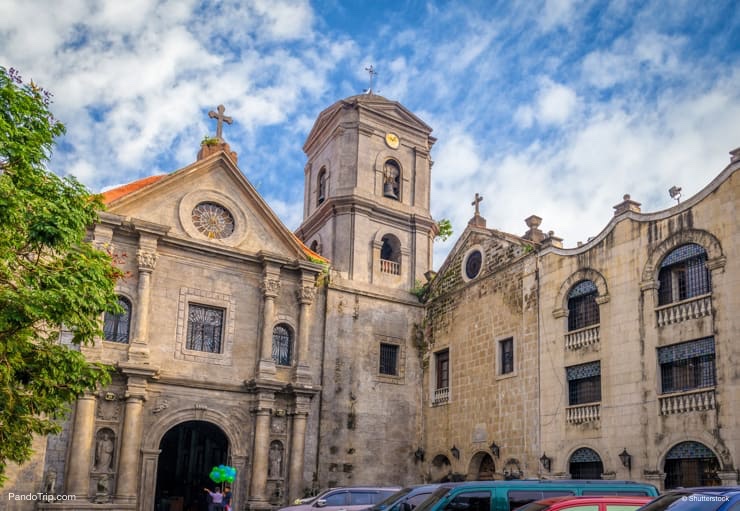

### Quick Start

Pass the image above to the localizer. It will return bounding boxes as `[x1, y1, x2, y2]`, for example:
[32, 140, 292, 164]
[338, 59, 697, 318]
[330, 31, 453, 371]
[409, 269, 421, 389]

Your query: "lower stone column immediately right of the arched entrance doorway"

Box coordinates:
[249, 392, 275, 509]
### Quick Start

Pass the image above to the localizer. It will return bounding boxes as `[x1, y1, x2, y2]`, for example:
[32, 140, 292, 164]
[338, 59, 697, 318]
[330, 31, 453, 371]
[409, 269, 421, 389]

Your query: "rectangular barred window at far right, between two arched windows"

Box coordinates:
[658, 337, 715, 394]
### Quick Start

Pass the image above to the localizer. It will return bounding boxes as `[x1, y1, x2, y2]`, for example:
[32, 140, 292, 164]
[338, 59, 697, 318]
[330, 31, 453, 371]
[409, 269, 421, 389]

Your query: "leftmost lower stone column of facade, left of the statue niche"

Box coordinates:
[66, 393, 96, 499]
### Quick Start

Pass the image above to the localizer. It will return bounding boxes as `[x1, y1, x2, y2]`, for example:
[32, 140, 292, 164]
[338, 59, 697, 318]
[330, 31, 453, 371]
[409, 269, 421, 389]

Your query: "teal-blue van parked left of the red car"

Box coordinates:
[414, 479, 658, 511]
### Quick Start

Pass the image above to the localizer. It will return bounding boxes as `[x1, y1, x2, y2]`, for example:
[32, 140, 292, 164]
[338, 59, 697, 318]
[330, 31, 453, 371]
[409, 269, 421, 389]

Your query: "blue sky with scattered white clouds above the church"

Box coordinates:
[0, 0, 740, 266]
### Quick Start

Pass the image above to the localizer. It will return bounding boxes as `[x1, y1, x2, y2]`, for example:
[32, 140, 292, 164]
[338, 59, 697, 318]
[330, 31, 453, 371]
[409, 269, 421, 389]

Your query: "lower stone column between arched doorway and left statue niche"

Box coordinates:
[116, 368, 150, 504]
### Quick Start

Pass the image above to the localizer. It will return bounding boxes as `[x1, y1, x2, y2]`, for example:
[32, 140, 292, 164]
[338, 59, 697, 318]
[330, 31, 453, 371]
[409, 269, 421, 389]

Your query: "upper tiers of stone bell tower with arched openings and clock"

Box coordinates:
[296, 93, 437, 290]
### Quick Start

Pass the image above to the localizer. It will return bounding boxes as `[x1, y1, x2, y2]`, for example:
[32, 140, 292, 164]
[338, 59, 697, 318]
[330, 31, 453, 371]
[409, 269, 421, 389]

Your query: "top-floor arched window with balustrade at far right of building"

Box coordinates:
[658, 243, 712, 305]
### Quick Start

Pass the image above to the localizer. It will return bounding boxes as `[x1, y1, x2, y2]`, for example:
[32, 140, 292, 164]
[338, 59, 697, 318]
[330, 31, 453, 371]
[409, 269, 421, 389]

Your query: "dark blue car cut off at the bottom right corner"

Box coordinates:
[638, 486, 740, 511]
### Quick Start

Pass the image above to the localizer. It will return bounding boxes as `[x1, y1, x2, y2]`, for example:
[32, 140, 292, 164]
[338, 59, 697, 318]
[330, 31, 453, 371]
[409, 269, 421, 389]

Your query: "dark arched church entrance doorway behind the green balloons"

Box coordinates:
[154, 421, 229, 511]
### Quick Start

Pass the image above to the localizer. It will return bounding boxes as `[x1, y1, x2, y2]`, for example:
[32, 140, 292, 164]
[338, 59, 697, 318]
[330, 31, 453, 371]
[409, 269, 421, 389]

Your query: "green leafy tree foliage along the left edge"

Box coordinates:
[0, 67, 121, 486]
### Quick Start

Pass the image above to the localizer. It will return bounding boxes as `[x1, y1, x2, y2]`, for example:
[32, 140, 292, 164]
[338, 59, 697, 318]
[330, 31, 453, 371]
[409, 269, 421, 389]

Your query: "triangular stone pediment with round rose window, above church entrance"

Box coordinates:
[103, 148, 308, 260]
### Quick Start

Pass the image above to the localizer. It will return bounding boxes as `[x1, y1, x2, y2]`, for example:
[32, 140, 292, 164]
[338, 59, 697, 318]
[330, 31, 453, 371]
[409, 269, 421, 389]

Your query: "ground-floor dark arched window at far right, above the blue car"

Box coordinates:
[663, 442, 721, 490]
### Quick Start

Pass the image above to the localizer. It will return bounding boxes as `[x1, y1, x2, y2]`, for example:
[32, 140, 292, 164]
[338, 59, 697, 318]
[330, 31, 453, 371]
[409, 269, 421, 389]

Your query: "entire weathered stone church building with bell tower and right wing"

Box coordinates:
[3, 94, 740, 511]
